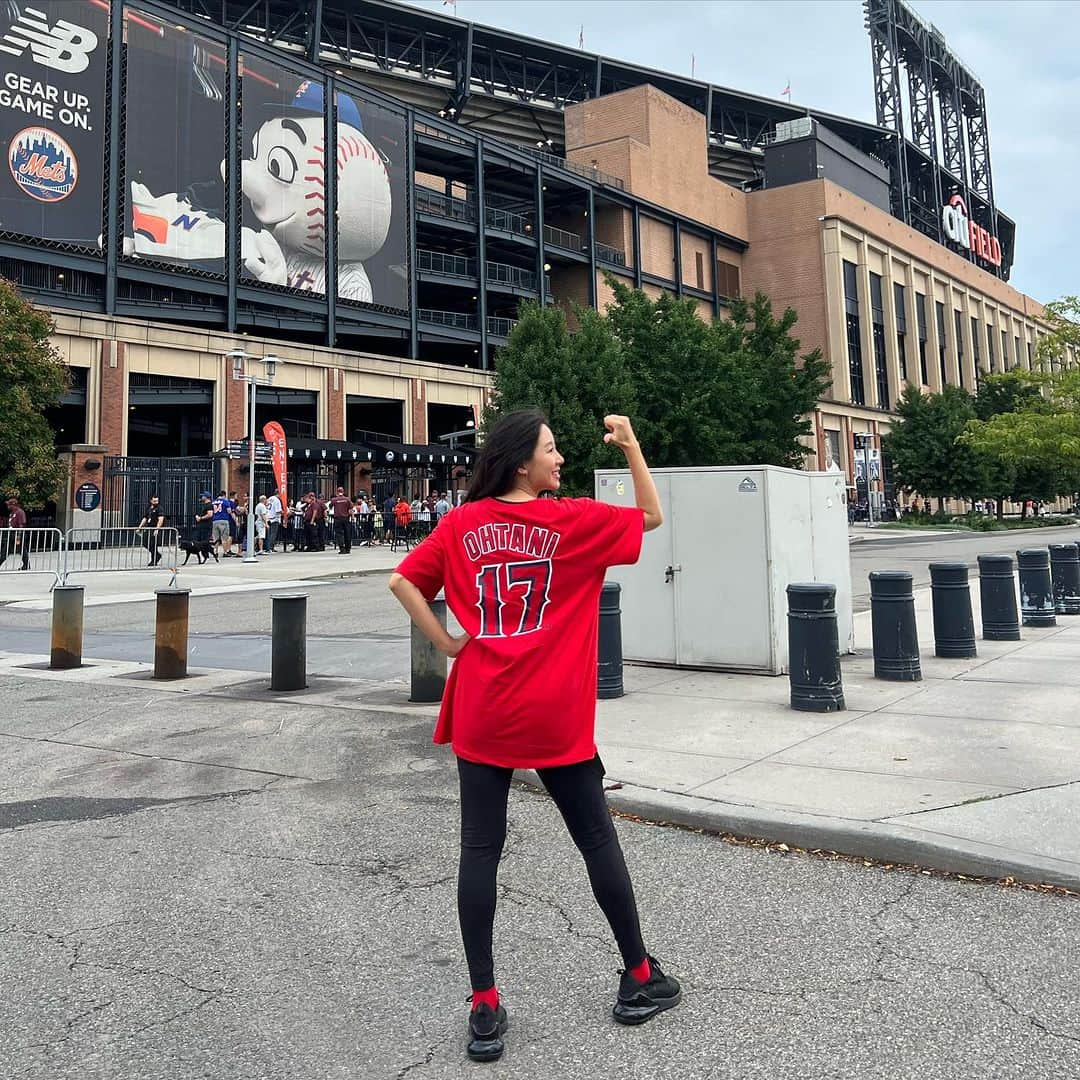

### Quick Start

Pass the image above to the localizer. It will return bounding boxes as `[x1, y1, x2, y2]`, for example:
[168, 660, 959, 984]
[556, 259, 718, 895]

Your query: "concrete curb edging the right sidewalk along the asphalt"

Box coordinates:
[516, 769, 1080, 891]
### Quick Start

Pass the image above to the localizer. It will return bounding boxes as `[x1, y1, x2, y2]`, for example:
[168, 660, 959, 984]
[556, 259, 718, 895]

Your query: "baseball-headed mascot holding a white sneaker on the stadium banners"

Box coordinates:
[125, 82, 393, 303]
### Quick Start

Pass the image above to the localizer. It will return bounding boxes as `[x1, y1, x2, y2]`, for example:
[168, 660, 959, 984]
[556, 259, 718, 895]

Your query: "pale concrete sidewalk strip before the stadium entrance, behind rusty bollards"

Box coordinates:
[0, 545, 405, 611]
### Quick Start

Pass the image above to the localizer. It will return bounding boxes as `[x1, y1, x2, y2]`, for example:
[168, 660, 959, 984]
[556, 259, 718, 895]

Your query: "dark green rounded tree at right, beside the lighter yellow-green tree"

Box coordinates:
[883, 383, 985, 512]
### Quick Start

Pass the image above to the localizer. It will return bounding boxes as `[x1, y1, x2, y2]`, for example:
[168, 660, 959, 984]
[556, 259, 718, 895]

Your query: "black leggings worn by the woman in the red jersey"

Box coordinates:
[458, 757, 645, 990]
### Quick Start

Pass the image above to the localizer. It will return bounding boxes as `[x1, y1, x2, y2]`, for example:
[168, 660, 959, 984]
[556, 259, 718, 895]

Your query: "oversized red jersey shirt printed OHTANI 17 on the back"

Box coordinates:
[397, 499, 645, 769]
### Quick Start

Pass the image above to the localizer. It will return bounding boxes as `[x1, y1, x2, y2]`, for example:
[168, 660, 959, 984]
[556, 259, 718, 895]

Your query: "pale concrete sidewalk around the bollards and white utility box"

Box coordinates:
[578, 580, 1080, 889]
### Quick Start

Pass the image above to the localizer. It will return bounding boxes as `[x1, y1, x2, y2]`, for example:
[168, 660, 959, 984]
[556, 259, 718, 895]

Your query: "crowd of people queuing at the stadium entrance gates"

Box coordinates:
[174, 487, 463, 558]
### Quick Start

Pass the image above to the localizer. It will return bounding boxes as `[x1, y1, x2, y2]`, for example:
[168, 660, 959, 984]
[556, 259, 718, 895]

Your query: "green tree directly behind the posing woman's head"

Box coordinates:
[484, 301, 634, 495]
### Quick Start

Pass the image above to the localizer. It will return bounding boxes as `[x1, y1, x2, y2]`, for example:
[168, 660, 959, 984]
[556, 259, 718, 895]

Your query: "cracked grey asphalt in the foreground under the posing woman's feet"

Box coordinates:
[0, 677, 1080, 1080]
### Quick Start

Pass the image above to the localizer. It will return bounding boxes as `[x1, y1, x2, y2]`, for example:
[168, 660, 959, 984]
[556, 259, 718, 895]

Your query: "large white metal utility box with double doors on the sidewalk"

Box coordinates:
[595, 465, 854, 675]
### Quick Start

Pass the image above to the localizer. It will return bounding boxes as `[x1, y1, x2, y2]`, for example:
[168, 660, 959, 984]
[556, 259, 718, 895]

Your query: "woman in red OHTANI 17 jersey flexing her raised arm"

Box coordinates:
[390, 409, 681, 1061]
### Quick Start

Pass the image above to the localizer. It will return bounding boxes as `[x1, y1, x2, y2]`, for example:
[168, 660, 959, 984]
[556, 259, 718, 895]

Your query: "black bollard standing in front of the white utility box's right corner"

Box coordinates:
[787, 582, 845, 713]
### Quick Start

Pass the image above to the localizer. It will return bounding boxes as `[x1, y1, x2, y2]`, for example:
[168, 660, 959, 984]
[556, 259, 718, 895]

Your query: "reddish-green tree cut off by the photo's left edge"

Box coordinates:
[0, 279, 70, 507]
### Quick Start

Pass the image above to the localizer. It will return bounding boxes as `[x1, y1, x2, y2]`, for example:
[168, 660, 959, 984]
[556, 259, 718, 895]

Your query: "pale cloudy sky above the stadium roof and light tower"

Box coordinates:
[410, 0, 1080, 300]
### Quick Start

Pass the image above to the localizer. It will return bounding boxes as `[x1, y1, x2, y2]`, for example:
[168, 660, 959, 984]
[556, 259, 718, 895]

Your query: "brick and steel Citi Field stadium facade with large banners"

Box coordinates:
[6, 0, 1071, 519]
